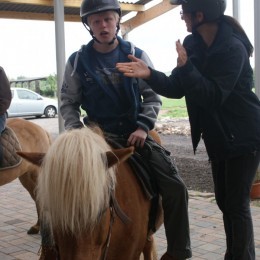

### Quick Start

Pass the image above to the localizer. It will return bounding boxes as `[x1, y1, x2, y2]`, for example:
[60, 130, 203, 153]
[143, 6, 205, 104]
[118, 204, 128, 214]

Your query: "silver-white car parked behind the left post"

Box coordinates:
[7, 88, 58, 117]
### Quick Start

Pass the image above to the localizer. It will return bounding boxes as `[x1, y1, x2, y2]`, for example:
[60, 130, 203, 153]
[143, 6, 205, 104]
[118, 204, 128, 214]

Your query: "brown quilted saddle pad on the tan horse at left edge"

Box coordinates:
[0, 127, 22, 171]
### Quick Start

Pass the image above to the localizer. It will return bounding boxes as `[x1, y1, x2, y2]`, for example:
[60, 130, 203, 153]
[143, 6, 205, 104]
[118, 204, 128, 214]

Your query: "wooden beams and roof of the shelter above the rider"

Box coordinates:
[0, 0, 176, 36]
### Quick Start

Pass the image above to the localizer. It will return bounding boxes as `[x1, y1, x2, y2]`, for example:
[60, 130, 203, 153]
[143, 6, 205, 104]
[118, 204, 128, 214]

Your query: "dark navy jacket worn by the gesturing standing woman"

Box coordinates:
[145, 18, 260, 160]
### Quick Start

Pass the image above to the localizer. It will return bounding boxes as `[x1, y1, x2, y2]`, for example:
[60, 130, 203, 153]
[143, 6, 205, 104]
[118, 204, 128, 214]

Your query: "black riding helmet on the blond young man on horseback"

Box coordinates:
[80, 0, 121, 22]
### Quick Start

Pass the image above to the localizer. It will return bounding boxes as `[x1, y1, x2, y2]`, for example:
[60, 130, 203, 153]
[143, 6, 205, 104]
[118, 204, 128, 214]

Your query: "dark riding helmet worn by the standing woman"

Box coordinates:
[170, 0, 227, 22]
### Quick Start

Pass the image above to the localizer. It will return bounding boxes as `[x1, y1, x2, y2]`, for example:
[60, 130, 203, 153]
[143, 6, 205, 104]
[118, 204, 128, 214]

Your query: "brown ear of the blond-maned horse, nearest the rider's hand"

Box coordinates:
[106, 146, 134, 167]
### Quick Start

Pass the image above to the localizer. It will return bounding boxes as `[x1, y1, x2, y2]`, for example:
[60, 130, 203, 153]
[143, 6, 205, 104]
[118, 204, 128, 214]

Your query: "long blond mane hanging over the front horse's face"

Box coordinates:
[37, 128, 115, 236]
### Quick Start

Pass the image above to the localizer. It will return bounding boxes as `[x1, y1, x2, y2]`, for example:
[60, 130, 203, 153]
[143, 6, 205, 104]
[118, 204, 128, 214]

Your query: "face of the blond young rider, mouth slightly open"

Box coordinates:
[88, 11, 119, 43]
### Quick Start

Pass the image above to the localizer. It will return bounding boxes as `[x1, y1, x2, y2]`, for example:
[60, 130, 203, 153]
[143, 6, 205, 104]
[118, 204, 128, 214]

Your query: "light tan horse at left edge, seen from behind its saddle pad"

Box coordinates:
[0, 118, 51, 234]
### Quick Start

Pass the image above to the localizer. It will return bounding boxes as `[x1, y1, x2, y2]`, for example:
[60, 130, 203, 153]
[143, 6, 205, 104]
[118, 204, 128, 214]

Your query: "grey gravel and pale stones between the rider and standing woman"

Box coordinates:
[156, 118, 214, 193]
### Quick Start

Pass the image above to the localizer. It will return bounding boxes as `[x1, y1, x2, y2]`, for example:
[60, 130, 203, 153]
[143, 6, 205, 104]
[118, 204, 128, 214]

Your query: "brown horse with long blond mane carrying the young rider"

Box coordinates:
[19, 128, 162, 260]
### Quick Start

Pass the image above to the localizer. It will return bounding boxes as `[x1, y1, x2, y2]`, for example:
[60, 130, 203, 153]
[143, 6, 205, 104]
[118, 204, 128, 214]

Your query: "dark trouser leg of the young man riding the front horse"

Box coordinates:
[137, 137, 192, 259]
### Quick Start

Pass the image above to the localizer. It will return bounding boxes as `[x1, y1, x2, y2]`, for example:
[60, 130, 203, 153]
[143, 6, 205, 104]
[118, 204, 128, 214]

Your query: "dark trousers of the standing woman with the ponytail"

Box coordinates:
[212, 151, 260, 260]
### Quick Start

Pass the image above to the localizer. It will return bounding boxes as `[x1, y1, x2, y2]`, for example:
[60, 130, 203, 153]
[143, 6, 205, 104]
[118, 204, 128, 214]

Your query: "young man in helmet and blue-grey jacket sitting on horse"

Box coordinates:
[60, 0, 191, 260]
